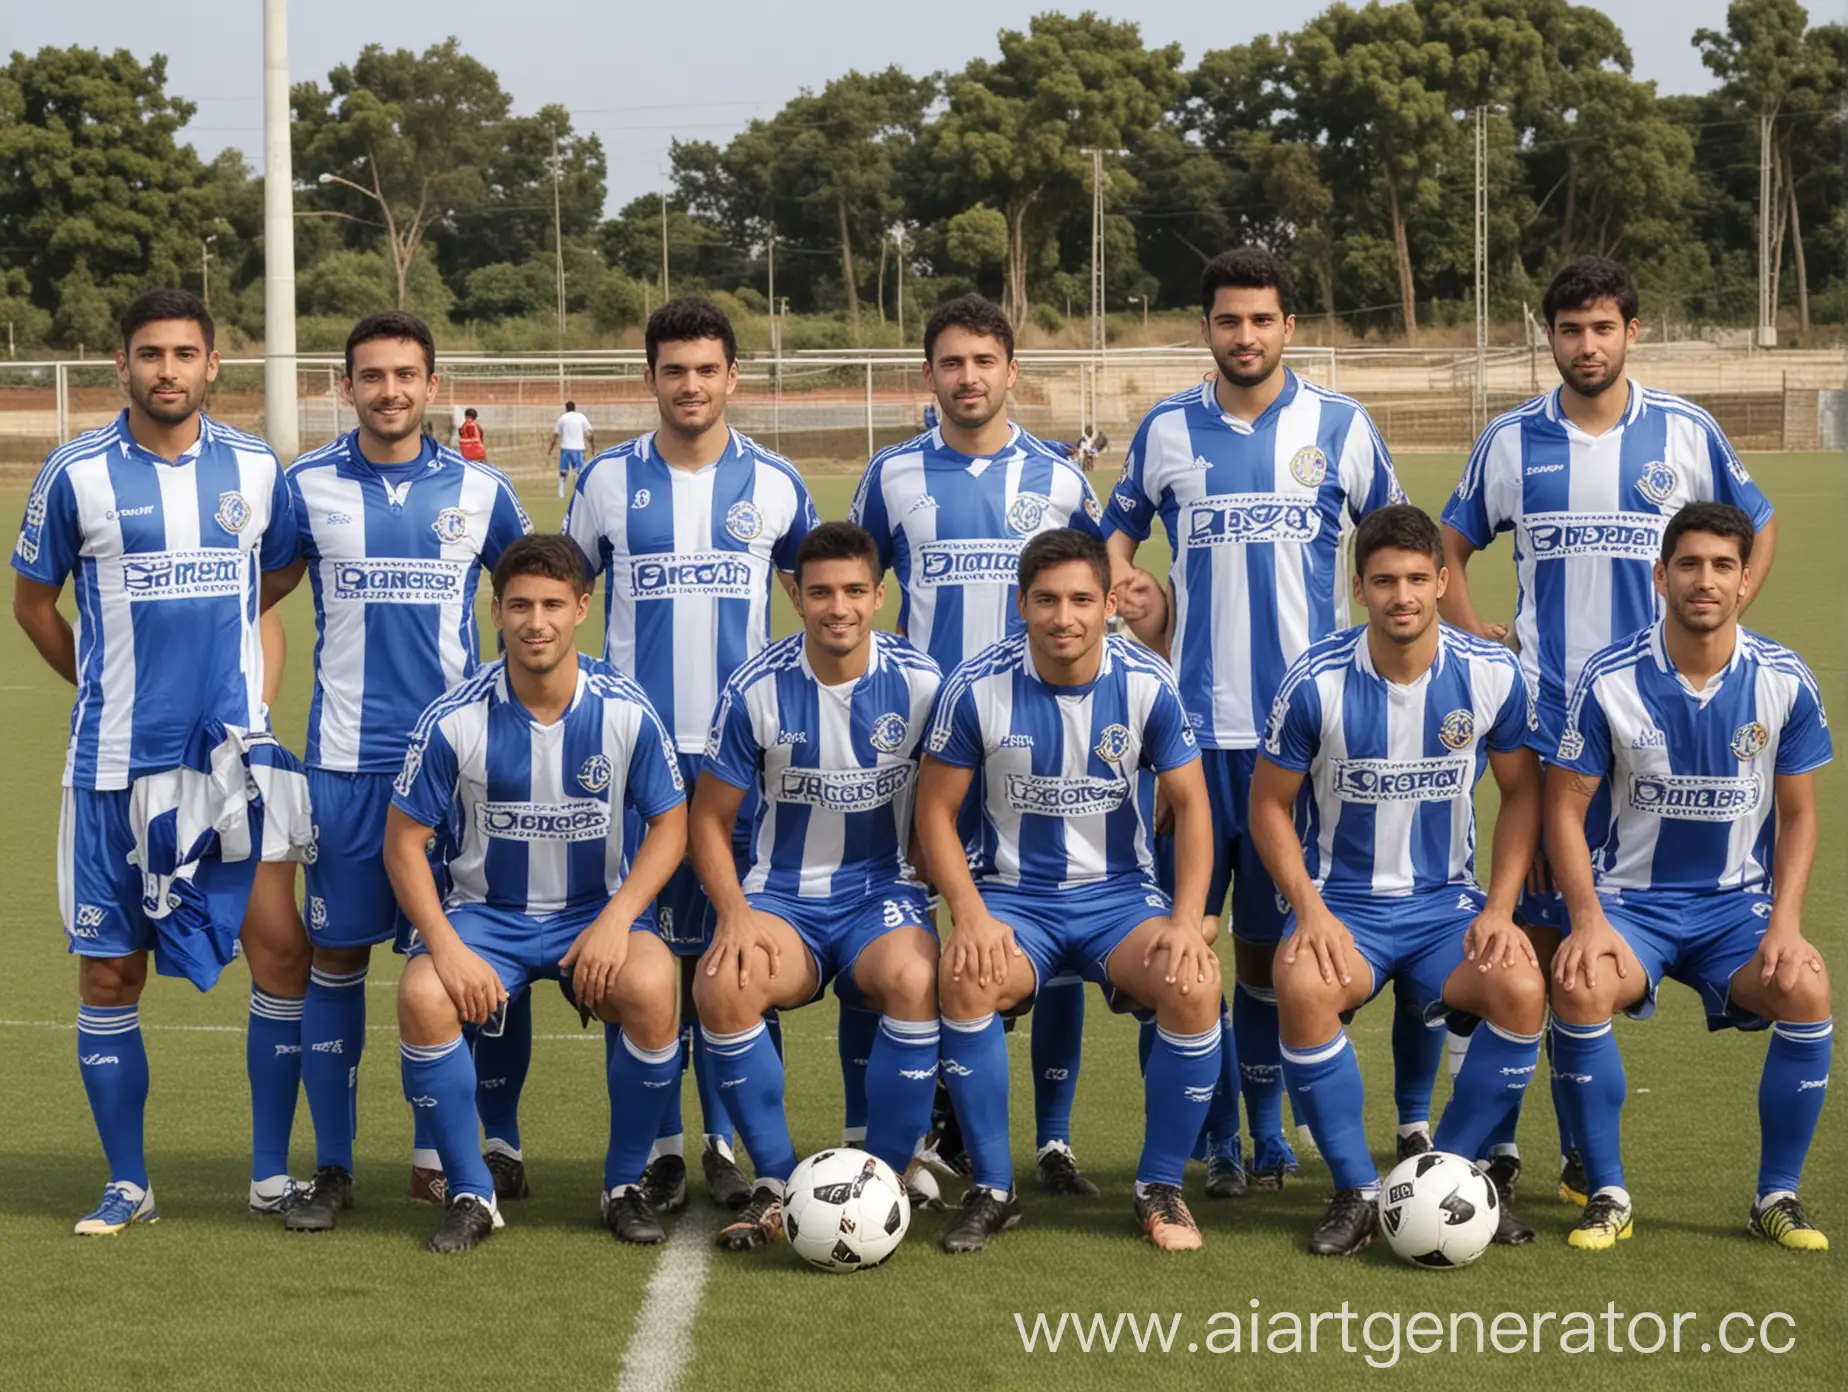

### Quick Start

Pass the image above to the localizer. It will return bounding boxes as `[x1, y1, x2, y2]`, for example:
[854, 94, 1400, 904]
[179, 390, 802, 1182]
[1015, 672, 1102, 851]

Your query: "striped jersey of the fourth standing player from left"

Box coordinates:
[846, 425, 1101, 671]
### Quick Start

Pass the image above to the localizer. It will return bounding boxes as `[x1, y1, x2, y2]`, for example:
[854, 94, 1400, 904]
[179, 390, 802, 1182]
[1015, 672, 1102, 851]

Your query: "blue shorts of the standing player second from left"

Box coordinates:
[301, 769, 405, 946]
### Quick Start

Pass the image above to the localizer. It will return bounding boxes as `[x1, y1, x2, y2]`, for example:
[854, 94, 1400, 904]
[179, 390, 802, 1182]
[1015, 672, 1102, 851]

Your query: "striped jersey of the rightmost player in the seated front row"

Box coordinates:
[1556, 623, 1835, 893]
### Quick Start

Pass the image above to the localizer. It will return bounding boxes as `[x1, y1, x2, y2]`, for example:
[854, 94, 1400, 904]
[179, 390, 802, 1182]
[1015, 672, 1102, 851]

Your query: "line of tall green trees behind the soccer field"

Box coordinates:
[0, 0, 1848, 348]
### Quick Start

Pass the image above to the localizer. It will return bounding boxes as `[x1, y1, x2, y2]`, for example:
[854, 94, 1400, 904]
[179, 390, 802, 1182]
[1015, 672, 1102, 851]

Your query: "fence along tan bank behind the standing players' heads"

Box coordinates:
[0, 344, 1848, 473]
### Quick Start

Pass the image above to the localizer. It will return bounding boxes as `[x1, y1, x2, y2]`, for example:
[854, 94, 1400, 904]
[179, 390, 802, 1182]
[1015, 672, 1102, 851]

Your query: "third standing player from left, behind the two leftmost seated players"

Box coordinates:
[565, 298, 819, 1211]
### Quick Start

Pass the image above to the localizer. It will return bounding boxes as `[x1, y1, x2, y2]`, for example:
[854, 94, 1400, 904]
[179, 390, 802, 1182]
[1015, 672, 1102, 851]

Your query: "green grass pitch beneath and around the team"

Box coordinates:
[0, 455, 1848, 1390]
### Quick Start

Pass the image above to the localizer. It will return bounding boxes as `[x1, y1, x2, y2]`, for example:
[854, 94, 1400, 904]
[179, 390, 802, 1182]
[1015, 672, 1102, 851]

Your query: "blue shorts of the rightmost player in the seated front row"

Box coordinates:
[1599, 889, 1770, 1030]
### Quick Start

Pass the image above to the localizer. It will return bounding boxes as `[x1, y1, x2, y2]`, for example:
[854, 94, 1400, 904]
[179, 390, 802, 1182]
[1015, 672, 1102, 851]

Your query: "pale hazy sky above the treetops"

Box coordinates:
[6, 0, 1744, 214]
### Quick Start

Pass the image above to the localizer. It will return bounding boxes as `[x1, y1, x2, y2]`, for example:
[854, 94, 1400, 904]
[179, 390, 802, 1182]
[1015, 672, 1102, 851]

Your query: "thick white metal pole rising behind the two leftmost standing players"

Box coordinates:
[262, 0, 301, 460]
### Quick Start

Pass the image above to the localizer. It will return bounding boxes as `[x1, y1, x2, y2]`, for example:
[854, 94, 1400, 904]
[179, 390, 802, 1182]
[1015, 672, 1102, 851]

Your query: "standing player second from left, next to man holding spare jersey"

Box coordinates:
[264, 311, 532, 1231]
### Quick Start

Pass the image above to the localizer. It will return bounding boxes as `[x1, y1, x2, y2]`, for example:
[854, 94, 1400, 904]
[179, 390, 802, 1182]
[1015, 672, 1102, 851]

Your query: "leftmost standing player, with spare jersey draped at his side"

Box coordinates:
[13, 290, 309, 1235]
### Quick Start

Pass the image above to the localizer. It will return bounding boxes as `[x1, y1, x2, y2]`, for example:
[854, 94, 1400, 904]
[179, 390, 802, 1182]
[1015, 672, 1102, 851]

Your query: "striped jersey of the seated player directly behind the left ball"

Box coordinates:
[702, 632, 942, 900]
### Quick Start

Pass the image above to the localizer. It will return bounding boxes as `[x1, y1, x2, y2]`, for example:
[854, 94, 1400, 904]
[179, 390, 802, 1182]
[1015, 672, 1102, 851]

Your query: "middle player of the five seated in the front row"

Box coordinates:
[917, 527, 1220, 1252]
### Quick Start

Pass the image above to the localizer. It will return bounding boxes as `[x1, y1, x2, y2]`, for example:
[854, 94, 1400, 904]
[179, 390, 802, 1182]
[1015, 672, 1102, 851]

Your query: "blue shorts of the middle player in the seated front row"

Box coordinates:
[979, 874, 1173, 1009]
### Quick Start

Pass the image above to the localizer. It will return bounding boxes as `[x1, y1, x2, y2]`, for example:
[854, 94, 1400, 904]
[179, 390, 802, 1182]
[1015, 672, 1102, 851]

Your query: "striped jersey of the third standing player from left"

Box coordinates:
[565, 431, 821, 754]
